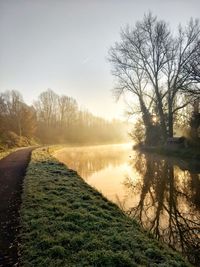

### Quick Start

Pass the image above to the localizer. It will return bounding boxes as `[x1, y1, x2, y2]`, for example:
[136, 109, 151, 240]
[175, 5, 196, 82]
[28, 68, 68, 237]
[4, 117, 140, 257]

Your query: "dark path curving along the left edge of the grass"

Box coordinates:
[0, 148, 33, 267]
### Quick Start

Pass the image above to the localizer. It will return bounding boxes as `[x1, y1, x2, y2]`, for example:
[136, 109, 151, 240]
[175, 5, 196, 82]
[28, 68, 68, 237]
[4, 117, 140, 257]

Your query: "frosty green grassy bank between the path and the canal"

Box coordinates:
[20, 148, 189, 267]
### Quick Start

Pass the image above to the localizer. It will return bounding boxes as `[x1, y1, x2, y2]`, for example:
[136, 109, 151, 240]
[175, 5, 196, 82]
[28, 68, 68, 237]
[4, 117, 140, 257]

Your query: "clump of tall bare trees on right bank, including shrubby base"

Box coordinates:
[109, 13, 200, 145]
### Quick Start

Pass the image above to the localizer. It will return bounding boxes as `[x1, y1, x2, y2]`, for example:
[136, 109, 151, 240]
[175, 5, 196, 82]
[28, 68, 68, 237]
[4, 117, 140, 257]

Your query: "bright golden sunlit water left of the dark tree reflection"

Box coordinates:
[55, 144, 139, 207]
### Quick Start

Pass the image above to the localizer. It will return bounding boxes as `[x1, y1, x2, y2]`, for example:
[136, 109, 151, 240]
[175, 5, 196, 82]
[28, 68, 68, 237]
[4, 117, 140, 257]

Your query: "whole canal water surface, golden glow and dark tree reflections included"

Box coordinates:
[55, 144, 200, 266]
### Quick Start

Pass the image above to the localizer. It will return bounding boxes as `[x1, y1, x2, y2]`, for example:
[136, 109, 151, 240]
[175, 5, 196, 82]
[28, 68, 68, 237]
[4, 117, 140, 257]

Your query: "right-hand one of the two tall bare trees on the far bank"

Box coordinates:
[163, 19, 200, 136]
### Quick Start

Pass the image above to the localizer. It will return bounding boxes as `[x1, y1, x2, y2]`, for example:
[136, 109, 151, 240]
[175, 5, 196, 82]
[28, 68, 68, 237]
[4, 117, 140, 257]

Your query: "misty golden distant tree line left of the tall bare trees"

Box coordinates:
[0, 89, 126, 147]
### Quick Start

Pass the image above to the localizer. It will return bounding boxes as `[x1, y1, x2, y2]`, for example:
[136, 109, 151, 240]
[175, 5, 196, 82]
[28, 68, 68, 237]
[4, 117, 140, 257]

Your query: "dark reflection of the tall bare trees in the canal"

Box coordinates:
[125, 155, 200, 265]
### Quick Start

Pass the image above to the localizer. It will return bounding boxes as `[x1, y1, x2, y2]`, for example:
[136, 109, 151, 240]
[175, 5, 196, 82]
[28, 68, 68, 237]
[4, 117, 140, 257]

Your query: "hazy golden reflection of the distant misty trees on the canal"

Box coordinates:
[57, 145, 128, 178]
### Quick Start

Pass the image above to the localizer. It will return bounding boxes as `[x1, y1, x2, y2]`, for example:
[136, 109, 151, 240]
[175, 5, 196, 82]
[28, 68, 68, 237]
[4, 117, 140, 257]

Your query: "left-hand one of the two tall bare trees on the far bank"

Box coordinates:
[109, 13, 170, 140]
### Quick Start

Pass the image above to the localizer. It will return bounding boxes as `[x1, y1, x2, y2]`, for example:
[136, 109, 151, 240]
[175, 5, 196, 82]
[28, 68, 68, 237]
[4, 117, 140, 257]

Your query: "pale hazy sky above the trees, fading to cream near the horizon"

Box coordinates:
[0, 0, 200, 118]
